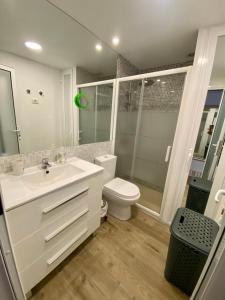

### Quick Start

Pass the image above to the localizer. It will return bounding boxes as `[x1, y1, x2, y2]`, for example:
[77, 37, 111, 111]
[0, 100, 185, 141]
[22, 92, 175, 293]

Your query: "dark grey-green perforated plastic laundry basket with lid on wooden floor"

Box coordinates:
[165, 208, 219, 295]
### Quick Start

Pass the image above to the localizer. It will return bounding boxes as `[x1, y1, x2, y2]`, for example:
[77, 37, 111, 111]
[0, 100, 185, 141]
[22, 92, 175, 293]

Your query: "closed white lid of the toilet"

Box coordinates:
[104, 177, 140, 200]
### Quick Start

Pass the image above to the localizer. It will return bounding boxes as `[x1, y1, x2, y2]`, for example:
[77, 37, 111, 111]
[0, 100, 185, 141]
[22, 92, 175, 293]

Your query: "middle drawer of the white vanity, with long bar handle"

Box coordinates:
[14, 206, 88, 271]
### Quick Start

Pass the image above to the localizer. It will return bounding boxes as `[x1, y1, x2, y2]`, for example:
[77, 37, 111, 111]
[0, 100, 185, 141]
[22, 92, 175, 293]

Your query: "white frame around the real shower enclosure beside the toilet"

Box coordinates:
[112, 66, 193, 223]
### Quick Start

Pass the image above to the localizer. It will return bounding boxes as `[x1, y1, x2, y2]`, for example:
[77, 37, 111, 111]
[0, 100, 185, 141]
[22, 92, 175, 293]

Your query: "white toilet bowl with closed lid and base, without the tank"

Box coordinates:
[103, 177, 140, 220]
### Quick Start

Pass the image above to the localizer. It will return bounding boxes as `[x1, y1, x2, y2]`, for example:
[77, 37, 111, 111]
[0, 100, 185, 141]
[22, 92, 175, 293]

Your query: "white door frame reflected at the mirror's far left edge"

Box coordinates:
[0, 64, 23, 154]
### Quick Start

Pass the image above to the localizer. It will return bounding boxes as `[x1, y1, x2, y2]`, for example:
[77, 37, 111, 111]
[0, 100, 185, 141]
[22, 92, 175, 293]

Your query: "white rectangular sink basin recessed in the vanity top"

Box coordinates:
[22, 164, 84, 188]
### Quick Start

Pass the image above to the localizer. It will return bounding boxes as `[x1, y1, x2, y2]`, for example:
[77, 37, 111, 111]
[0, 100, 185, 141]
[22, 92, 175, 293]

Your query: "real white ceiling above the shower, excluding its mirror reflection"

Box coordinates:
[49, 0, 225, 69]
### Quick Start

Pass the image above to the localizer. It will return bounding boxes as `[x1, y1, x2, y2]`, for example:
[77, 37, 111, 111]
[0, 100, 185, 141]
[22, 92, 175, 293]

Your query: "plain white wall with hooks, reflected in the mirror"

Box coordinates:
[0, 51, 62, 152]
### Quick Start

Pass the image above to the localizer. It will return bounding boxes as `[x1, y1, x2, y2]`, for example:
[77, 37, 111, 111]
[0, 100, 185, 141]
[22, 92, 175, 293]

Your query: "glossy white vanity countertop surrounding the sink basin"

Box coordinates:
[0, 158, 104, 211]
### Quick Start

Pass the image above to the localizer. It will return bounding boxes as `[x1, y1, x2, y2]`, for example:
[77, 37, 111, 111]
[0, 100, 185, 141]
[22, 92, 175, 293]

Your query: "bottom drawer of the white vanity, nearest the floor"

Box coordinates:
[19, 213, 100, 293]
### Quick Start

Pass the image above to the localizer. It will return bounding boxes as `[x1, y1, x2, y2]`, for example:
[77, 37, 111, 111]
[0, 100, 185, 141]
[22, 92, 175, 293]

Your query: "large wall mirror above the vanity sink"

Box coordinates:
[0, 0, 117, 156]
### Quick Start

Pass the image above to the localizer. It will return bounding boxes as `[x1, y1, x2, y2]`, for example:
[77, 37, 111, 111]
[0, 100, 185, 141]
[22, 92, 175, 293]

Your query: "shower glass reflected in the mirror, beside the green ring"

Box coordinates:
[79, 83, 113, 144]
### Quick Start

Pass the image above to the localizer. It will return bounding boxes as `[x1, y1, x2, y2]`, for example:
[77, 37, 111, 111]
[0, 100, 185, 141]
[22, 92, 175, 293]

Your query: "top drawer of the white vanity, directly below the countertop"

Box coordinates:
[6, 174, 102, 244]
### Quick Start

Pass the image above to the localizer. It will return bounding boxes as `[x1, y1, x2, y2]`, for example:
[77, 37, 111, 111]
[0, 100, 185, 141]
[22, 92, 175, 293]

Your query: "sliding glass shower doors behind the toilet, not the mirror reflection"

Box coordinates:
[115, 73, 186, 213]
